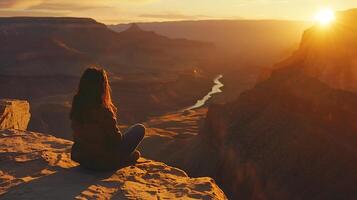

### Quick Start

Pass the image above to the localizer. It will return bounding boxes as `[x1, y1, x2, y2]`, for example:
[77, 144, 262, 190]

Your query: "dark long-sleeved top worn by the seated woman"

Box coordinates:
[71, 108, 122, 169]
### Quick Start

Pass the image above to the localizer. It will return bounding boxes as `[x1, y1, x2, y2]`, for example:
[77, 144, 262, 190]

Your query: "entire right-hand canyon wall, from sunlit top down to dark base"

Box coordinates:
[160, 10, 357, 200]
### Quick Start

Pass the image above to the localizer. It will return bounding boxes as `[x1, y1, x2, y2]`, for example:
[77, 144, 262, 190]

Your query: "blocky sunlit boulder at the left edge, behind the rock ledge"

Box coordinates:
[0, 99, 31, 130]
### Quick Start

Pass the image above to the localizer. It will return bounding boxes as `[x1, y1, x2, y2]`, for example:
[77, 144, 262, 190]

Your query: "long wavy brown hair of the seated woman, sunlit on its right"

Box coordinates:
[70, 67, 117, 123]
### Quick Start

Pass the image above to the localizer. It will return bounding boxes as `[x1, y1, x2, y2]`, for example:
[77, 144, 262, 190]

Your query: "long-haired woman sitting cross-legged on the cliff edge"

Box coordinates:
[70, 68, 145, 170]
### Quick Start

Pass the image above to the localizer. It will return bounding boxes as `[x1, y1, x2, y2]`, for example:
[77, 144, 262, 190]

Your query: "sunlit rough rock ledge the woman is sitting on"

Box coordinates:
[0, 130, 226, 199]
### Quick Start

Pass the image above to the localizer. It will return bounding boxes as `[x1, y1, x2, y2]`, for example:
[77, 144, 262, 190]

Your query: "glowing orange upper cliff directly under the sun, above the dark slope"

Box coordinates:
[262, 9, 357, 91]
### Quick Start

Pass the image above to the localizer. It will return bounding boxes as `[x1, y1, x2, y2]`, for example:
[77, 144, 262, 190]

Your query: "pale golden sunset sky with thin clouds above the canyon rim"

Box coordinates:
[0, 0, 357, 24]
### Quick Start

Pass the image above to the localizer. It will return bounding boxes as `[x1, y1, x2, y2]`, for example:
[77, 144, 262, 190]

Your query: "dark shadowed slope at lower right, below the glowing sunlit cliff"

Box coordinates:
[203, 67, 357, 199]
